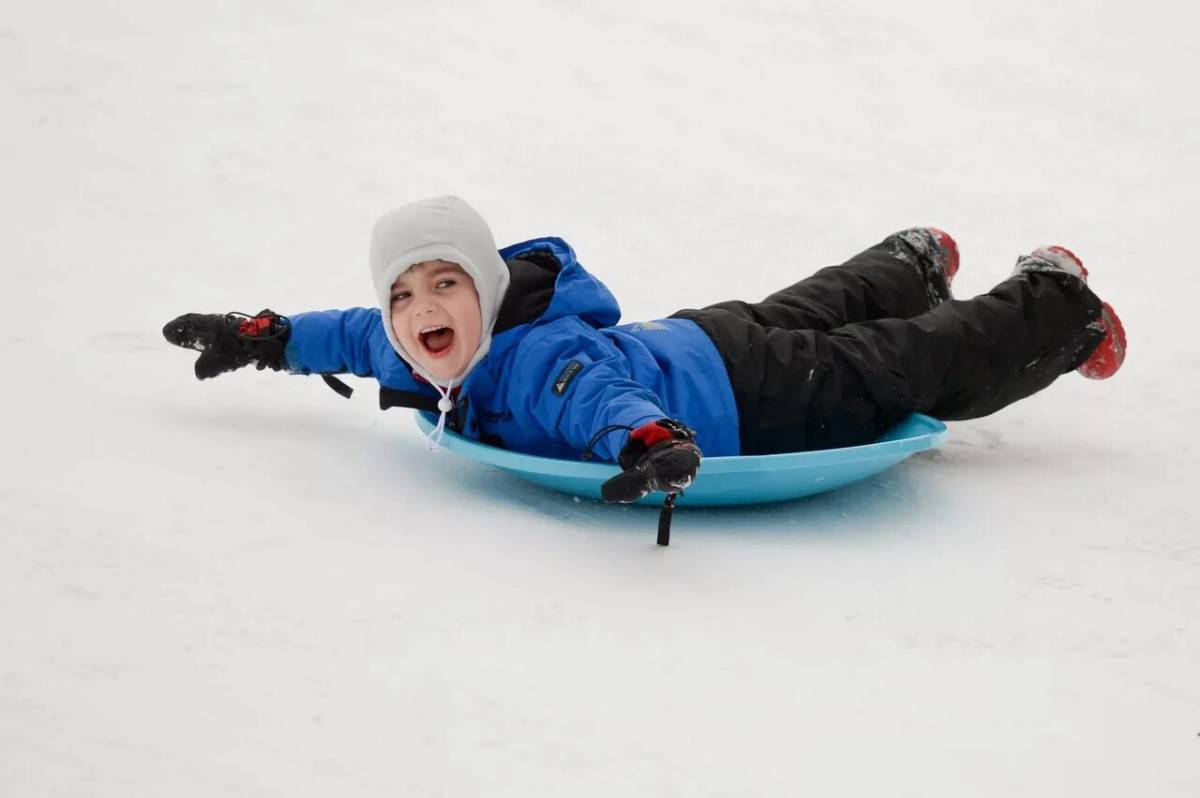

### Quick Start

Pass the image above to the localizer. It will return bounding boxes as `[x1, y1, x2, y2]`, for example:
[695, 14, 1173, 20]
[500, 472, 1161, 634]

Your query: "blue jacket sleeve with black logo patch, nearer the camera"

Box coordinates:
[510, 318, 666, 462]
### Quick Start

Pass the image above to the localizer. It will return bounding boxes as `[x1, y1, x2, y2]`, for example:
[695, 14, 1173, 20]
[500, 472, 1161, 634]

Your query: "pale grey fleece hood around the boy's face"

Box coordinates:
[371, 196, 509, 388]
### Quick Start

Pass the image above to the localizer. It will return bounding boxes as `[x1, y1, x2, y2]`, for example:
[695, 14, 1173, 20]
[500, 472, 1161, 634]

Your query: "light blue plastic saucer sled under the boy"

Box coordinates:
[415, 413, 946, 506]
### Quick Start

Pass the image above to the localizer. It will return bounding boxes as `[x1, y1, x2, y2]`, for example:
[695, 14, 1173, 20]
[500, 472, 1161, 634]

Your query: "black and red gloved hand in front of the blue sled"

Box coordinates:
[600, 419, 701, 504]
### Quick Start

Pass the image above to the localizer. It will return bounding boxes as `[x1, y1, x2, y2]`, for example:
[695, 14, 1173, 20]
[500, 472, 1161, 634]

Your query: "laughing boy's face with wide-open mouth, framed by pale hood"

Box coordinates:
[391, 260, 482, 380]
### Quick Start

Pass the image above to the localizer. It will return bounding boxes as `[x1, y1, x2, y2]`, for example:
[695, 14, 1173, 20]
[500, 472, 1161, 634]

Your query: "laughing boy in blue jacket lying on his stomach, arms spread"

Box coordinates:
[163, 197, 1126, 502]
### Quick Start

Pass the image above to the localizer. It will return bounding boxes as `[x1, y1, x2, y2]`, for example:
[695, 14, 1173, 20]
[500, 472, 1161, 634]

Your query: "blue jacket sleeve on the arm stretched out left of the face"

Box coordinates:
[284, 307, 390, 377]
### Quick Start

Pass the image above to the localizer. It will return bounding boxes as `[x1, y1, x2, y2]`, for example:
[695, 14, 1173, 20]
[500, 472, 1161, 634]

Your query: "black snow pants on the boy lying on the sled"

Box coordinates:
[673, 229, 1104, 455]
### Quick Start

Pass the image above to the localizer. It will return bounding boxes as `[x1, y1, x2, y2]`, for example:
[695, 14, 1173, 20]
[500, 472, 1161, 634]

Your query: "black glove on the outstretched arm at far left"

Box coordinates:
[162, 310, 292, 379]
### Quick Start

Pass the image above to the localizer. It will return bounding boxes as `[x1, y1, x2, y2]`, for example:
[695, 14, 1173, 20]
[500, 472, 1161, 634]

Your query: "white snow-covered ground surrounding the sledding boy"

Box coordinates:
[0, 0, 1200, 798]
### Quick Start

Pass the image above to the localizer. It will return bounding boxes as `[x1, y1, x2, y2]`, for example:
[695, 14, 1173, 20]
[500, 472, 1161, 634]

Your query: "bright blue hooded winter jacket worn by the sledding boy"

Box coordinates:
[286, 238, 739, 462]
